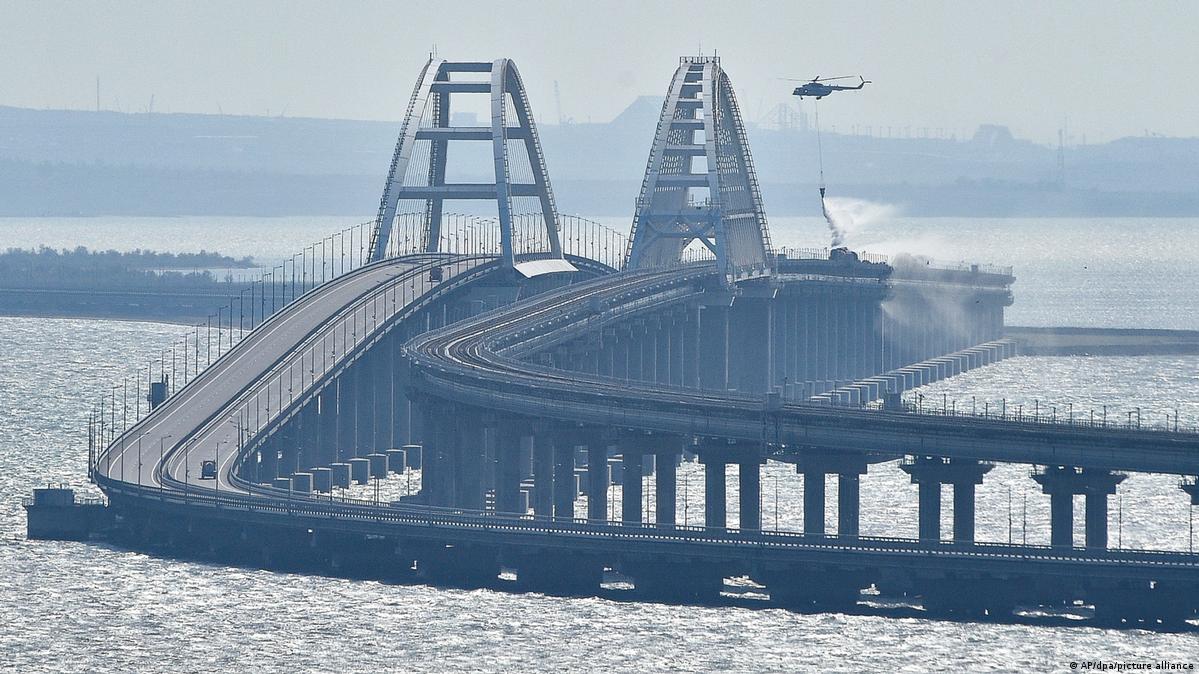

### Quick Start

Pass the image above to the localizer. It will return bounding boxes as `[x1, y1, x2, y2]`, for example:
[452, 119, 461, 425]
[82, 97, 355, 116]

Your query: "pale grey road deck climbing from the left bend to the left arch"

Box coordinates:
[96, 253, 490, 492]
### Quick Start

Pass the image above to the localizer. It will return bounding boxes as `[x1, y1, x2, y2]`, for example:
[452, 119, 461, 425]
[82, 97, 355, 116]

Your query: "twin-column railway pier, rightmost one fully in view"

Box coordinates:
[1032, 465, 1125, 549]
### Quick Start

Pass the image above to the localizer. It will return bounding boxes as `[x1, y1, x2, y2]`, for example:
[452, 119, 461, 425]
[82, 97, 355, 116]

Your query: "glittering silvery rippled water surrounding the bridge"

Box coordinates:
[0, 218, 1199, 672]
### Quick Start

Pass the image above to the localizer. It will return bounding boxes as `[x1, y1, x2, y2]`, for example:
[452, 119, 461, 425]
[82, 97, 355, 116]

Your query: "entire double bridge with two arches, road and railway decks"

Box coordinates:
[74, 58, 1199, 626]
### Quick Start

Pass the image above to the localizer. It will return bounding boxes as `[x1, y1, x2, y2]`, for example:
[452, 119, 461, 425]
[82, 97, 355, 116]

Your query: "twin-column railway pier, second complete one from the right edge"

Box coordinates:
[900, 456, 993, 543]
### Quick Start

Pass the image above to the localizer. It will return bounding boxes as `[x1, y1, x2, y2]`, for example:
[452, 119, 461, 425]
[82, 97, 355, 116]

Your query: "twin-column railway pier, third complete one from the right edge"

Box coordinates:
[795, 451, 868, 538]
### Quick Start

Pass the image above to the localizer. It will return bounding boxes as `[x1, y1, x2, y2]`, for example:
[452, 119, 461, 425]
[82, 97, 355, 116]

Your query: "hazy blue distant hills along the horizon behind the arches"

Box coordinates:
[0, 104, 1199, 216]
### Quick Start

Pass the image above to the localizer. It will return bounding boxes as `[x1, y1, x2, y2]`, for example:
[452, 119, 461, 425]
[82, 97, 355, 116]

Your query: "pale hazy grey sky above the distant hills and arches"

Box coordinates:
[0, 0, 1199, 142]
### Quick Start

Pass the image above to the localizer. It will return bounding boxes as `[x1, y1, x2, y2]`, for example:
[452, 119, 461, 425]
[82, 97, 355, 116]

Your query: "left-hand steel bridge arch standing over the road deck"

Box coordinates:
[370, 58, 562, 267]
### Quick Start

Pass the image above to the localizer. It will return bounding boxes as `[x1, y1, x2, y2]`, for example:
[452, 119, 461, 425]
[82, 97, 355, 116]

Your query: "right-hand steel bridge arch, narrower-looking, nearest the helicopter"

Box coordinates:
[626, 56, 771, 281]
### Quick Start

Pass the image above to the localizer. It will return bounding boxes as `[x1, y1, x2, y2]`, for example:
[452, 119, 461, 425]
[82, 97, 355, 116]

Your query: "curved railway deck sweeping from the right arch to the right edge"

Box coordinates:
[405, 260, 1199, 475]
